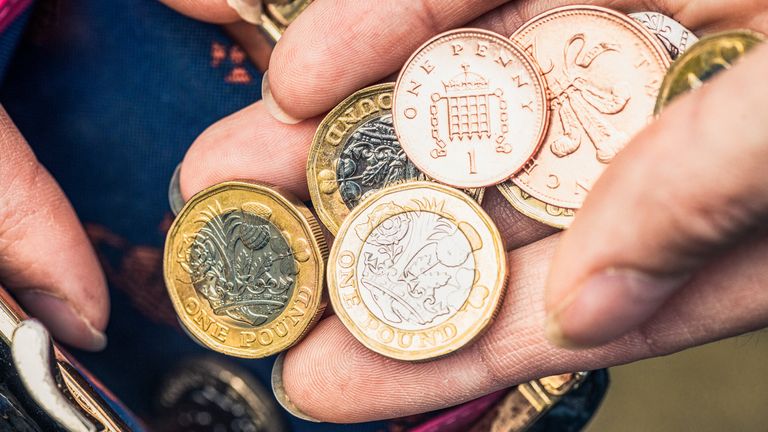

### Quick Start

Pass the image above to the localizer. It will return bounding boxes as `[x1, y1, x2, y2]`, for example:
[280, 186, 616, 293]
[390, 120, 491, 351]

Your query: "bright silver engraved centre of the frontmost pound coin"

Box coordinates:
[356, 209, 476, 330]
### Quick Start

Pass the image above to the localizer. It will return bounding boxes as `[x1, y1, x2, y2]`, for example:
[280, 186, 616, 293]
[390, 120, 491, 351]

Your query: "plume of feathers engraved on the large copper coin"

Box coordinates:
[548, 34, 631, 164]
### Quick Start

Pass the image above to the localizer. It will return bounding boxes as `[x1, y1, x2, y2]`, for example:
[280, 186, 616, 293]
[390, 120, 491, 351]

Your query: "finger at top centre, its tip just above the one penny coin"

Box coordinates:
[262, 0, 505, 123]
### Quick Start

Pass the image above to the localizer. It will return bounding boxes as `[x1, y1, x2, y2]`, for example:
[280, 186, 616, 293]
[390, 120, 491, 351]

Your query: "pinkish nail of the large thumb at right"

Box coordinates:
[545, 269, 689, 349]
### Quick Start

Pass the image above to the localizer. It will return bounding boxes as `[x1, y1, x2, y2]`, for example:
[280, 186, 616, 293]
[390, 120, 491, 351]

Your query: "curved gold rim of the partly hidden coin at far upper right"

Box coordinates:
[653, 29, 768, 116]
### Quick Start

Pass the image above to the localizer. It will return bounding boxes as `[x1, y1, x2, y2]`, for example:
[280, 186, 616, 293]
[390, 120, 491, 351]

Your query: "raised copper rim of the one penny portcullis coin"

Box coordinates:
[392, 27, 551, 189]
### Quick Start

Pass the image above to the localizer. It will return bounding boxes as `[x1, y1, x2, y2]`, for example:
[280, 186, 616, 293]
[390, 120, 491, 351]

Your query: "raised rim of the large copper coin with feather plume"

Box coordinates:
[510, 5, 672, 210]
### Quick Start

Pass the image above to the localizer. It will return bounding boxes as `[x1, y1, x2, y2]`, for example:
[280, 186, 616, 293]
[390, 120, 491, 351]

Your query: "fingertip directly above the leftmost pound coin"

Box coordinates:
[180, 102, 319, 201]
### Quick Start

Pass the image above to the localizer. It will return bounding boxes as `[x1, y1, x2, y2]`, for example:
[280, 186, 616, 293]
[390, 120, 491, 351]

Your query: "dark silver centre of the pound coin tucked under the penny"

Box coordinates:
[336, 114, 423, 210]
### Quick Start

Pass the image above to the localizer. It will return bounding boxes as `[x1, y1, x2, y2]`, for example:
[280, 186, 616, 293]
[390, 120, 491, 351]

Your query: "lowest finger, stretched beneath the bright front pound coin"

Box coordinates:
[275, 236, 768, 423]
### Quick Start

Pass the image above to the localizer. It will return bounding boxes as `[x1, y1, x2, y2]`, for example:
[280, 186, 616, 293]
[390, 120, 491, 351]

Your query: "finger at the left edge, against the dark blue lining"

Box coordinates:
[0, 108, 109, 350]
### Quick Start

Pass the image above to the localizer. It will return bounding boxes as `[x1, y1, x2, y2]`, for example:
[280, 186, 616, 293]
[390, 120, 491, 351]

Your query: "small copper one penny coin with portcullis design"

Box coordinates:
[393, 29, 549, 188]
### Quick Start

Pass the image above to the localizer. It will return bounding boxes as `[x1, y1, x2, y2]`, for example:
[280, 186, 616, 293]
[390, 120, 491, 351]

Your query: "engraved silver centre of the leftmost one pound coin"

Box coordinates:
[180, 203, 298, 326]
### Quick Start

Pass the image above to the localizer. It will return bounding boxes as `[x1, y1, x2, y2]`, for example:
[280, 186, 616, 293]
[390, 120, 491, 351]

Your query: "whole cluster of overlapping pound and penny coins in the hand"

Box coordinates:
[165, 5, 764, 361]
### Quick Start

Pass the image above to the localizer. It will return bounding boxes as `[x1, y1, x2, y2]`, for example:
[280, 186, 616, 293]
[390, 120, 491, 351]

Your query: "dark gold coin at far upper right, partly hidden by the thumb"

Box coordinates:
[656, 30, 766, 113]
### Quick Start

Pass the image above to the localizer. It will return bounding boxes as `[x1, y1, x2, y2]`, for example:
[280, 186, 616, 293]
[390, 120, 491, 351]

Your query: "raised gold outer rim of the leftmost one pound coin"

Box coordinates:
[163, 180, 328, 359]
